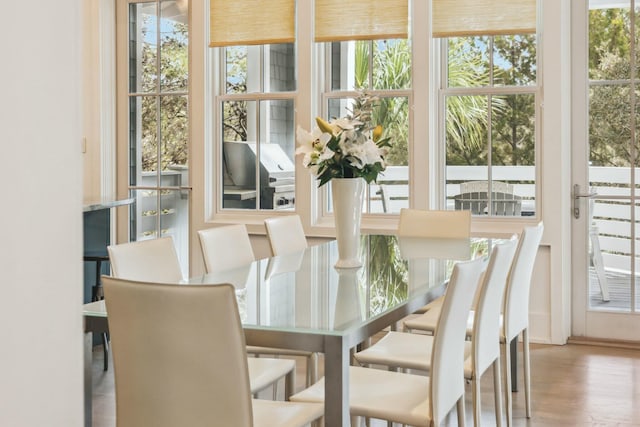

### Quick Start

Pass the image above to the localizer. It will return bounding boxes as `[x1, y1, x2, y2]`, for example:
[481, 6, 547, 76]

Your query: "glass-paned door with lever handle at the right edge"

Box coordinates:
[573, 0, 640, 341]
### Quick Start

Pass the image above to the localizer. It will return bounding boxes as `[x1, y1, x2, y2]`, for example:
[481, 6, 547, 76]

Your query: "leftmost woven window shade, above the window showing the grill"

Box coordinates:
[209, 0, 296, 47]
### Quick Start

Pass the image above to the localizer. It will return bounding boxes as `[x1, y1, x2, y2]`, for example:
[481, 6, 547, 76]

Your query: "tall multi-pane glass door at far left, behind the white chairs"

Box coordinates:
[117, 0, 190, 274]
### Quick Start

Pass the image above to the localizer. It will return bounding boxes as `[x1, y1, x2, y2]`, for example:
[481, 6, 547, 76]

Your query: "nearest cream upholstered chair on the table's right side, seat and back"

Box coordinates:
[291, 258, 484, 426]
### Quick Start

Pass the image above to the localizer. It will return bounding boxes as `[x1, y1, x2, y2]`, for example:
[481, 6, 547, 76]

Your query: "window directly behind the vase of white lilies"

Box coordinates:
[323, 39, 412, 213]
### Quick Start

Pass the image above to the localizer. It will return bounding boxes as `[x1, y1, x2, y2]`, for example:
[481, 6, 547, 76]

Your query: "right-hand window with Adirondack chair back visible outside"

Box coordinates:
[439, 34, 539, 216]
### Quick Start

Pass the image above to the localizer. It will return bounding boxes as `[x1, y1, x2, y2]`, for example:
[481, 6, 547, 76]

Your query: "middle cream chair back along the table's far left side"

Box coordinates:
[198, 224, 255, 273]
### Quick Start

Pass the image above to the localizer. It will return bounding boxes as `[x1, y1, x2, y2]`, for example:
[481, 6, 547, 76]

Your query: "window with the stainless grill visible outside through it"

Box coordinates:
[218, 43, 296, 210]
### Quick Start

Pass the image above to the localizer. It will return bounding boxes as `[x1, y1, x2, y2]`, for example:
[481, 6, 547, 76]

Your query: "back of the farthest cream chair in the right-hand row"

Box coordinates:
[503, 221, 544, 342]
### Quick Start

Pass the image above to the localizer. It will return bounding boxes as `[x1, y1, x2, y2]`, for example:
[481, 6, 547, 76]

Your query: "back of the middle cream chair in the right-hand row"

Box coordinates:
[471, 239, 518, 376]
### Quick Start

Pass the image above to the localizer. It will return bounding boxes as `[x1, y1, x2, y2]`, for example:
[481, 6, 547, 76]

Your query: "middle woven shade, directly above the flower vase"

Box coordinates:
[315, 0, 409, 42]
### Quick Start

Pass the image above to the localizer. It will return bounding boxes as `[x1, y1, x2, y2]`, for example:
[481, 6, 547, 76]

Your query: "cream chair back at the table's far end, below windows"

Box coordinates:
[398, 208, 471, 239]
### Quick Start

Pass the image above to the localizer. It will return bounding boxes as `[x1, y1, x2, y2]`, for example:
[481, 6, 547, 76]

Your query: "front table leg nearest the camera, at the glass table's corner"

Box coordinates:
[324, 337, 350, 427]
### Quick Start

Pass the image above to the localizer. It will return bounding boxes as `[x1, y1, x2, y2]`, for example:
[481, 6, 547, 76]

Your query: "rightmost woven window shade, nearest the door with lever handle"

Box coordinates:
[432, 0, 536, 37]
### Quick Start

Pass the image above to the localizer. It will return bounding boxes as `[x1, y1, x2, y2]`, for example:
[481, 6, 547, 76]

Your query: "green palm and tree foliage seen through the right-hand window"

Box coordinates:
[445, 36, 537, 169]
